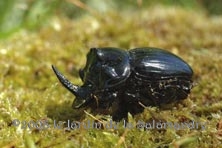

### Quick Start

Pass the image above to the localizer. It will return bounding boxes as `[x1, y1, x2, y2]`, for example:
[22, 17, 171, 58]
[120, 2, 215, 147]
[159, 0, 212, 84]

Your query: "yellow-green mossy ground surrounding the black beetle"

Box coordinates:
[0, 6, 222, 148]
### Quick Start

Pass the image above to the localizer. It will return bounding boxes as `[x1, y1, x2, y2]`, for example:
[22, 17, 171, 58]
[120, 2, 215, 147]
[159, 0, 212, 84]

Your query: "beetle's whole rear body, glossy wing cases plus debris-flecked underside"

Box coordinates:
[127, 48, 193, 108]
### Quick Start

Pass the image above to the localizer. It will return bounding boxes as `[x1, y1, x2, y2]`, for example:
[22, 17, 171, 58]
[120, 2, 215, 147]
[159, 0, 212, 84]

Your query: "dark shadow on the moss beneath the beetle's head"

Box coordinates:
[46, 101, 85, 121]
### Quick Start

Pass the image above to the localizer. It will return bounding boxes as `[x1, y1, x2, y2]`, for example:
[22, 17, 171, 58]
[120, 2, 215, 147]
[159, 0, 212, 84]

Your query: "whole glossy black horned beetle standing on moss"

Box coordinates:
[52, 47, 193, 121]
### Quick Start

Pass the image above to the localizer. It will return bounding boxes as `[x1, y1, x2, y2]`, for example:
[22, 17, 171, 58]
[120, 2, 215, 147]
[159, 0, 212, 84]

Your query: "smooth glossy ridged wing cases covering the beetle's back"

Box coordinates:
[129, 48, 193, 79]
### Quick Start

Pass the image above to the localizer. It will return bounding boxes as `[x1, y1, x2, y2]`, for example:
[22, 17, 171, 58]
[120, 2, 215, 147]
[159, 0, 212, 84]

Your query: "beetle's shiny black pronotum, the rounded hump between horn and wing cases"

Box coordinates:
[79, 47, 130, 90]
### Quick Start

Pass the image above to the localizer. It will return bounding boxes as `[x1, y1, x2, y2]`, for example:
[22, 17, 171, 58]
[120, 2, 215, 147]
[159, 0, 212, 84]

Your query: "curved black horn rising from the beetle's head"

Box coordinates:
[52, 65, 79, 96]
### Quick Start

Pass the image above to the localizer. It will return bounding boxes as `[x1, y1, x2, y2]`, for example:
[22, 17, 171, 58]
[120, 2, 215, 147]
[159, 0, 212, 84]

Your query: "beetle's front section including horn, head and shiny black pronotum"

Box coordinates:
[52, 47, 130, 108]
